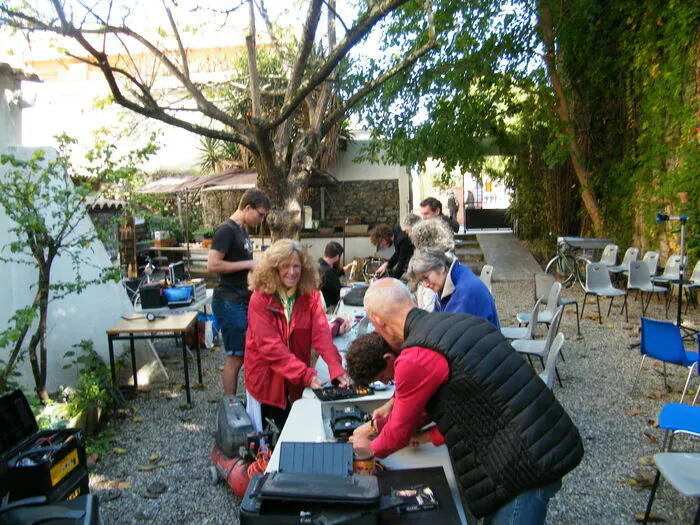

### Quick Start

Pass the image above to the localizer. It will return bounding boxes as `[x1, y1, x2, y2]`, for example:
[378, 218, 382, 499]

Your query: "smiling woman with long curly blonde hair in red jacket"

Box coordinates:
[244, 239, 349, 430]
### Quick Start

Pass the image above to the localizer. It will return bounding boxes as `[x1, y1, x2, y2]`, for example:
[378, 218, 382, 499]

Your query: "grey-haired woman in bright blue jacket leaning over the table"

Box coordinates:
[408, 248, 501, 328]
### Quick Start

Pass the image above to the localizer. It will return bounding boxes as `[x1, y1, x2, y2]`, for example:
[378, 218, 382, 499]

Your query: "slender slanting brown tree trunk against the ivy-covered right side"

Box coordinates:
[539, 1, 605, 237]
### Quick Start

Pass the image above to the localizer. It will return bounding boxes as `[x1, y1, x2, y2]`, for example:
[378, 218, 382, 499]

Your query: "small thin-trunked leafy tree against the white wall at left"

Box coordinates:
[0, 136, 154, 400]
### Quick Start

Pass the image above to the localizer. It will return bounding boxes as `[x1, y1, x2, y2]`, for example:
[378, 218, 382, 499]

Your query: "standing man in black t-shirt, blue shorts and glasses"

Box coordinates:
[207, 188, 270, 395]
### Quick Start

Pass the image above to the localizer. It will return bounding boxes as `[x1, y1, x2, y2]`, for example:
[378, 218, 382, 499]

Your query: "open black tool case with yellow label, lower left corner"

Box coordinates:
[0, 390, 89, 503]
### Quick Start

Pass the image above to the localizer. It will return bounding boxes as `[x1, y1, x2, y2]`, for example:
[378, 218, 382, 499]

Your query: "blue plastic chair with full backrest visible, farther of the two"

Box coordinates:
[632, 317, 700, 403]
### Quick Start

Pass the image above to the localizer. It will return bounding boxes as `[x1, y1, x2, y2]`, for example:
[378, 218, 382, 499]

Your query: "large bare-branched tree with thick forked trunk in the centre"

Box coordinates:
[0, 0, 437, 236]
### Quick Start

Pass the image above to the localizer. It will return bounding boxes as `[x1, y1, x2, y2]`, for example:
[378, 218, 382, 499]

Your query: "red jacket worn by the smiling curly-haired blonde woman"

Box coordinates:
[244, 290, 345, 409]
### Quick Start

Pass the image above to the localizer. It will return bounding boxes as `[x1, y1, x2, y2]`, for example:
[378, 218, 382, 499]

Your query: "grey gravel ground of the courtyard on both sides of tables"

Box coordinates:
[90, 282, 700, 525]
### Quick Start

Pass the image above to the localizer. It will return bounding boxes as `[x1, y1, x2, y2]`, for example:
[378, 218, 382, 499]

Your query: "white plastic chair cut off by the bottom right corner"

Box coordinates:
[642, 452, 700, 525]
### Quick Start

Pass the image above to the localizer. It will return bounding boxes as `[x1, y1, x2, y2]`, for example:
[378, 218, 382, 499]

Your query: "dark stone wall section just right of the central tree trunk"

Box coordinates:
[322, 179, 399, 226]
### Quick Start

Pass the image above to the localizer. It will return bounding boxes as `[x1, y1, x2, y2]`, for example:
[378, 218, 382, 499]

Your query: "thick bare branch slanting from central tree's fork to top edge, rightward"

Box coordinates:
[265, 0, 408, 129]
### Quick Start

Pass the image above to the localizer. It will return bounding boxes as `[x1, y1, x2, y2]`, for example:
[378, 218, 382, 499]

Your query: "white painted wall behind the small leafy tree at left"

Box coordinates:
[0, 148, 133, 392]
